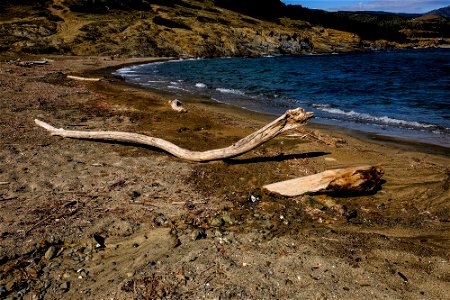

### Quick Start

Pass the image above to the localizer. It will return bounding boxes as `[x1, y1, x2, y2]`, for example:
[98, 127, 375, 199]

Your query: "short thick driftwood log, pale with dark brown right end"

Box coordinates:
[263, 166, 383, 197]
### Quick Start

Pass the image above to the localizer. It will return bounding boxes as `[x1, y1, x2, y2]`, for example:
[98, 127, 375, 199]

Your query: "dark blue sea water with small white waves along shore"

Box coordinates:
[117, 49, 450, 147]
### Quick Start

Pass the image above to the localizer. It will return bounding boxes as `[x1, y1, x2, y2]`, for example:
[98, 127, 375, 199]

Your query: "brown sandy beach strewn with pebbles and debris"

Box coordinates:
[0, 56, 450, 299]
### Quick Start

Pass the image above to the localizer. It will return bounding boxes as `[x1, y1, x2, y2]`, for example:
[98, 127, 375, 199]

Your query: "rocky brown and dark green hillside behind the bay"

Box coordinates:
[0, 0, 450, 57]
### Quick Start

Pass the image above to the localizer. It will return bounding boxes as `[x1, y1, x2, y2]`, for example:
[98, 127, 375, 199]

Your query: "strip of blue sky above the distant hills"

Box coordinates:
[281, 0, 450, 13]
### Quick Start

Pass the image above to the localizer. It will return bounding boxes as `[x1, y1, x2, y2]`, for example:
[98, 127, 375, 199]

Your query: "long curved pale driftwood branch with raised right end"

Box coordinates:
[34, 108, 314, 161]
